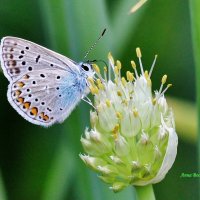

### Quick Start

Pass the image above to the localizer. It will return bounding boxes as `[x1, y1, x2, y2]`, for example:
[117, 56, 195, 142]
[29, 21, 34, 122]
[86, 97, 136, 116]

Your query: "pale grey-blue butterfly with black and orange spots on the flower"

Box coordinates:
[0, 37, 94, 127]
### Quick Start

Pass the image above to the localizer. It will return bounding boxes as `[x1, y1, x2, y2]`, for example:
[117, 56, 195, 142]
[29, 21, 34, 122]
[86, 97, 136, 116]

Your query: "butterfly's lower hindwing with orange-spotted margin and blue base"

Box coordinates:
[8, 69, 86, 126]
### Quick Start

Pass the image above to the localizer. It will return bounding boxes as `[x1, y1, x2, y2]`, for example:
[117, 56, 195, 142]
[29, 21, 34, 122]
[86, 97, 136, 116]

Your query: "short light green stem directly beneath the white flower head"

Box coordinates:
[135, 185, 156, 200]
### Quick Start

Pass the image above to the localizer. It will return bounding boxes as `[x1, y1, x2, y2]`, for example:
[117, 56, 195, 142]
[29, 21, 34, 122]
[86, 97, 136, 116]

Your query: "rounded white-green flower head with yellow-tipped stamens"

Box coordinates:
[80, 48, 178, 191]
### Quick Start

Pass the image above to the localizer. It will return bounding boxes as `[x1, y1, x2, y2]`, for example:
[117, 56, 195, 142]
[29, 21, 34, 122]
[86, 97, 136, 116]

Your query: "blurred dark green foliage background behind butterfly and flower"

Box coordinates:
[0, 0, 199, 200]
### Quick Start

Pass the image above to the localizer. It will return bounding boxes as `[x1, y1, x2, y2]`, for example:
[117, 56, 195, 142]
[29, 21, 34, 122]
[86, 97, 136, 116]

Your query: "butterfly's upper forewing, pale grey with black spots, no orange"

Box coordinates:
[0, 37, 79, 81]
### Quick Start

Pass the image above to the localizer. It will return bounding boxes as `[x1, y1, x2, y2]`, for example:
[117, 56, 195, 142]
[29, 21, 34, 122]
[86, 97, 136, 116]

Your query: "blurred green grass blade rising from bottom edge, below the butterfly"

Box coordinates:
[41, 140, 74, 200]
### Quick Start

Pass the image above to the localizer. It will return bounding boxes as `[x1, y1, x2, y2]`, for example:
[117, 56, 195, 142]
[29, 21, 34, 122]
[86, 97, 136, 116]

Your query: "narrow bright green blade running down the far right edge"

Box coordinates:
[190, 0, 200, 196]
